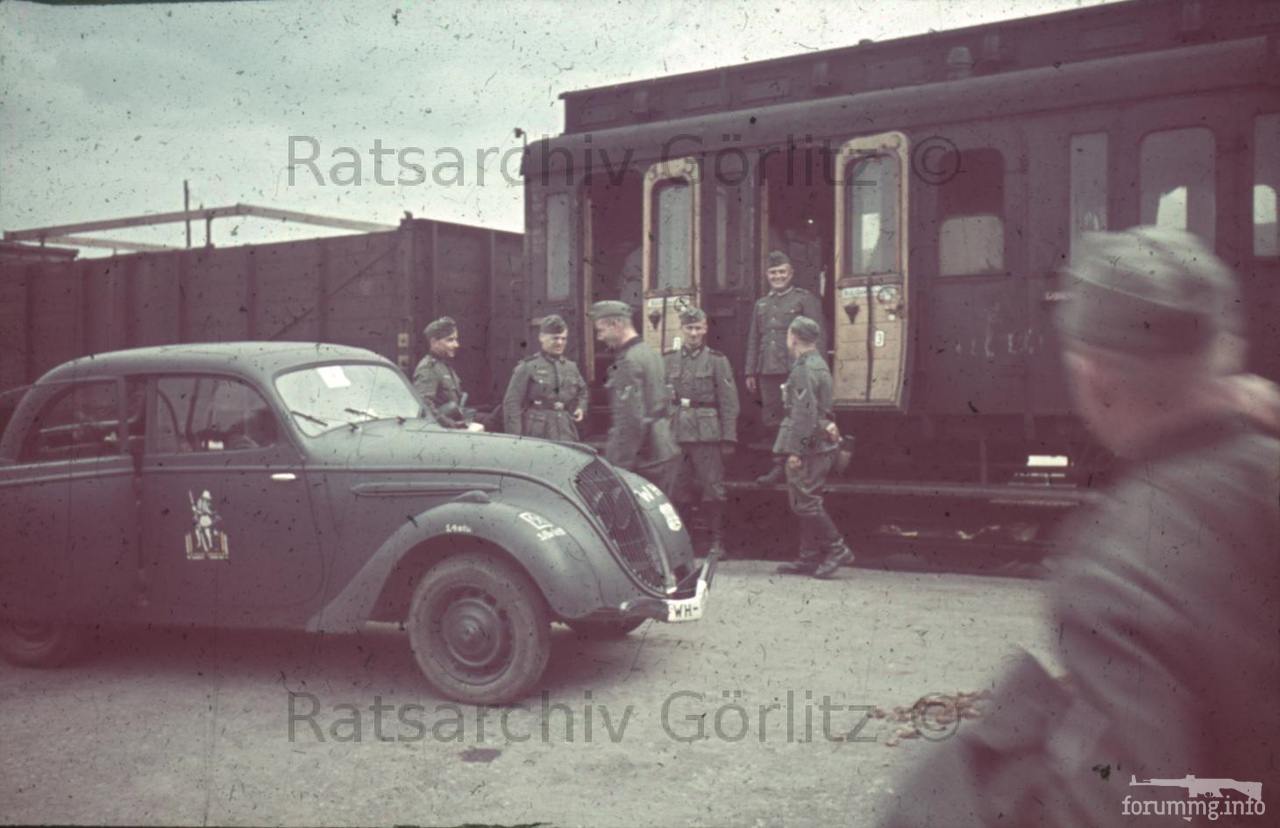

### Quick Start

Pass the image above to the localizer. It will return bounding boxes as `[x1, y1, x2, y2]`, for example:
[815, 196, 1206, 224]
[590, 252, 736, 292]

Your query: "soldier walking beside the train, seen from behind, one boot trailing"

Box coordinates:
[773, 316, 854, 578]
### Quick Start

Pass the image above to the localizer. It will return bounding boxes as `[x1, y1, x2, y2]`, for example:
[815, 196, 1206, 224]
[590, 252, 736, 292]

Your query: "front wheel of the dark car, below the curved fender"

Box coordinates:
[407, 553, 550, 704]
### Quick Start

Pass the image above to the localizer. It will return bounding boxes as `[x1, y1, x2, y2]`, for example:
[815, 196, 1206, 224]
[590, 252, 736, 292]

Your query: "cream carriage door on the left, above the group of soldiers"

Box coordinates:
[640, 159, 701, 351]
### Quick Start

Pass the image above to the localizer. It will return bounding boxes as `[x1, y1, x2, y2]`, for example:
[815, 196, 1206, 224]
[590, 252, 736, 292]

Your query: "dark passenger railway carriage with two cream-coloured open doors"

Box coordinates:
[524, 0, 1280, 499]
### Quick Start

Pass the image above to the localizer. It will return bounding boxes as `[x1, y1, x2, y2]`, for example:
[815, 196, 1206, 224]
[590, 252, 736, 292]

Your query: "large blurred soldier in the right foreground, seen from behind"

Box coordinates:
[887, 228, 1280, 827]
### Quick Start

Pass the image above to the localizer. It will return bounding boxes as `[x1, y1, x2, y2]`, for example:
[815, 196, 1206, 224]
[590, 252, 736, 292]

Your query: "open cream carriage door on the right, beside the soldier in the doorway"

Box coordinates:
[832, 132, 910, 408]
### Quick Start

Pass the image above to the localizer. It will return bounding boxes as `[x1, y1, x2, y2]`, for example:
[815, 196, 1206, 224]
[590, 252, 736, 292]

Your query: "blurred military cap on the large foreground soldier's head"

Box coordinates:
[1057, 227, 1240, 356]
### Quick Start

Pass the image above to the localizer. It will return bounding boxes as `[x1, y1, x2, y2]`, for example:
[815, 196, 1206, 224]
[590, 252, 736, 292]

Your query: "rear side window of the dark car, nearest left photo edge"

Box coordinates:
[18, 380, 120, 463]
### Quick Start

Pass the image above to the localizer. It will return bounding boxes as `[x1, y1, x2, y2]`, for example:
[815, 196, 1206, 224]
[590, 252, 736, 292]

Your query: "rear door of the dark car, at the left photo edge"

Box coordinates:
[0, 378, 141, 621]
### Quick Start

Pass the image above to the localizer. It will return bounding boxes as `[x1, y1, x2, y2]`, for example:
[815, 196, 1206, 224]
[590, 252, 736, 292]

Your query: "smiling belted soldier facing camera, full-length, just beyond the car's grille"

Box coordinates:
[664, 307, 737, 558]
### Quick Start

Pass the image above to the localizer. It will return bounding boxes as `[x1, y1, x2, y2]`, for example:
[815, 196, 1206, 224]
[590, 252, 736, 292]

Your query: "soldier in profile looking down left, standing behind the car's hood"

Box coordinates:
[591, 302, 680, 497]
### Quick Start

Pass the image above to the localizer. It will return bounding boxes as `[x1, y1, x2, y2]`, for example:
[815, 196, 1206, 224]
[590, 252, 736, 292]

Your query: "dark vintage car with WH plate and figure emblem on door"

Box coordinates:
[0, 342, 709, 704]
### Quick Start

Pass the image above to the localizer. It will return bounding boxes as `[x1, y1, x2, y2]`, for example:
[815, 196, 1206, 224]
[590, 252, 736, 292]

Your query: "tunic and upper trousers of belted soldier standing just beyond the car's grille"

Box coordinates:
[664, 347, 739, 502]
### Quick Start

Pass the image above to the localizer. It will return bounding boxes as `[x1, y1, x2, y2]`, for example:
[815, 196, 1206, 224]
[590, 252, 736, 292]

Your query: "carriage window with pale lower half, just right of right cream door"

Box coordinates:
[936, 148, 1005, 276]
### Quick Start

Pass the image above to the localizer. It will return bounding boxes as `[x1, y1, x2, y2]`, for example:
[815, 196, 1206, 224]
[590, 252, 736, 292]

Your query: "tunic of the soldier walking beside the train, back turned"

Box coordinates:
[773, 351, 838, 516]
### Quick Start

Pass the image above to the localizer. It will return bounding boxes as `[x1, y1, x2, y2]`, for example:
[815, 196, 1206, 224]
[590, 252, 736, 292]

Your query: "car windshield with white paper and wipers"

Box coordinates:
[275, 363, 424, 436]
